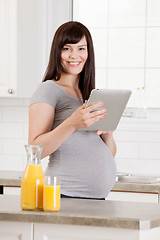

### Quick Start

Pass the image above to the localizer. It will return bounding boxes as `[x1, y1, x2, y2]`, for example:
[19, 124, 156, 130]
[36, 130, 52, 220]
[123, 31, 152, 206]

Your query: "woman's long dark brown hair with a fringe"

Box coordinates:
[43, 21, 95, 101]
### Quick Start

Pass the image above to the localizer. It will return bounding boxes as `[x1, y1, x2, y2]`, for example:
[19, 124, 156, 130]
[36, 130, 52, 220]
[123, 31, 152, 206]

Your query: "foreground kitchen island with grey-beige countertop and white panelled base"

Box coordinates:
[0, 195, 160, 240]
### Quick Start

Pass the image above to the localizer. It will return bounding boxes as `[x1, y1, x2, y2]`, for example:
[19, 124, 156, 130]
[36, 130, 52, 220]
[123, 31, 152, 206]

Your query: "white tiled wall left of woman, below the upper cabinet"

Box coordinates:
[0, 98, 47, 171]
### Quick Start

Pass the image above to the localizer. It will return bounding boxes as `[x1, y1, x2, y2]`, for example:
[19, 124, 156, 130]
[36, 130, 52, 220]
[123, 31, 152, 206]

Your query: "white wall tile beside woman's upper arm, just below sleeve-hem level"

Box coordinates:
[2, 107, 28, 122]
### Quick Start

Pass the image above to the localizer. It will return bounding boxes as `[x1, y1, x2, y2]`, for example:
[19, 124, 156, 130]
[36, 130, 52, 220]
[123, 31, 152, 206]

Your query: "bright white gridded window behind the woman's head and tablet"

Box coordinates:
[73, 0, 160, 108]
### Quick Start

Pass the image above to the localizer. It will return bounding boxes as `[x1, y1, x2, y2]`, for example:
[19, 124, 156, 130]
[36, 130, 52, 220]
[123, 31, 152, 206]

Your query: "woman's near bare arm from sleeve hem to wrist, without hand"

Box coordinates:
[28, 103, 74, 158]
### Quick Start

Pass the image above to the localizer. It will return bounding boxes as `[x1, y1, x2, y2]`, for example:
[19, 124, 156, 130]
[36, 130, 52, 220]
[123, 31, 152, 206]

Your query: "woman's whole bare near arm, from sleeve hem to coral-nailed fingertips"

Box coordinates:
[28, 103, 107, 158]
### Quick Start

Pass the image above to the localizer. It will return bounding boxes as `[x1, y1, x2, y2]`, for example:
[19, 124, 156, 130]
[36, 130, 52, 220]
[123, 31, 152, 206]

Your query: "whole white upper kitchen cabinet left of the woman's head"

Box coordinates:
[0, 0, 71, 98]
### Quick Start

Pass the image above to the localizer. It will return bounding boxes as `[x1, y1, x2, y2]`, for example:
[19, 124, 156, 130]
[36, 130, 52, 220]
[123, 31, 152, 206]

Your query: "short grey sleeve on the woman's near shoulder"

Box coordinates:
[30, 80, 57, 108]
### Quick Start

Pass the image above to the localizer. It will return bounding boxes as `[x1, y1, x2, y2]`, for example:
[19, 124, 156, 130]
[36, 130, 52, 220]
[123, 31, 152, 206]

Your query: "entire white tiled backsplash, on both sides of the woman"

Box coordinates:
[0, 98, 160, 176]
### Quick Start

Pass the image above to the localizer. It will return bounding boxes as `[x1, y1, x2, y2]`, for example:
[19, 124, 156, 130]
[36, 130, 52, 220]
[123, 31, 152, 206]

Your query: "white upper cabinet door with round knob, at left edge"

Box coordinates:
[0, 0, 17, 97]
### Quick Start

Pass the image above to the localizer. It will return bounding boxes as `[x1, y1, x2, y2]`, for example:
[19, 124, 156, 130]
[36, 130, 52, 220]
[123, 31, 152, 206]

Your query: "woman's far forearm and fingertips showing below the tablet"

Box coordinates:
[97, 131, 117, 157]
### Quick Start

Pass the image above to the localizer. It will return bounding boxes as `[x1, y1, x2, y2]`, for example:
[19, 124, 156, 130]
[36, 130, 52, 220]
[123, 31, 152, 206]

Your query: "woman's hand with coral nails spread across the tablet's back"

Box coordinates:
[68, 101, 107, 130]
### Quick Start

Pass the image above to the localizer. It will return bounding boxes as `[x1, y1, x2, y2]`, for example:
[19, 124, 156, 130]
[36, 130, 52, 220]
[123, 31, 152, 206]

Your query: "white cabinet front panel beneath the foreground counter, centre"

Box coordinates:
[34, 223, 140, 240]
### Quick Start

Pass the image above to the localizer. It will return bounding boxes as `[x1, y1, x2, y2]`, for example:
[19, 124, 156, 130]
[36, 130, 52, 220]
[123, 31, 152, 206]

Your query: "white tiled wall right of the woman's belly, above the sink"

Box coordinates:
[115, 115, 160, 176]
